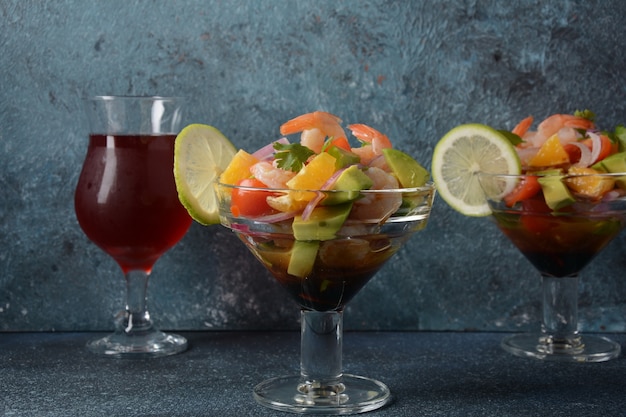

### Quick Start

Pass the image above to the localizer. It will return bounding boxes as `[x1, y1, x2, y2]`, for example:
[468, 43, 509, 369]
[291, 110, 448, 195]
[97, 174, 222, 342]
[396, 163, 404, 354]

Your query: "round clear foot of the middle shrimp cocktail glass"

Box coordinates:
[254, 374, 391, 415]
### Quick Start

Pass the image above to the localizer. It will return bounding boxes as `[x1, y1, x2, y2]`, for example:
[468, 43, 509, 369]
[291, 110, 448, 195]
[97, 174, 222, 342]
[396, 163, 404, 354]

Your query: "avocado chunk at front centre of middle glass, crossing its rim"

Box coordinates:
[292, 202, 352, 240]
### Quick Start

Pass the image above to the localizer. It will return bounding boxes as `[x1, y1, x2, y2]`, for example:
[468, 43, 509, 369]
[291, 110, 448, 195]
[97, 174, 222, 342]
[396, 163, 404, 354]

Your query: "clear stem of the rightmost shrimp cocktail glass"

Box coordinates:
[542, 275, 580, 349]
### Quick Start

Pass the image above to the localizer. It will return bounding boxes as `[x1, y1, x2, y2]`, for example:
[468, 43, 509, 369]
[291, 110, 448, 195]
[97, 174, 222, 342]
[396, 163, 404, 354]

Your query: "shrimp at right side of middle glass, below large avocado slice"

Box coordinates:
[350, 167, 402, 223]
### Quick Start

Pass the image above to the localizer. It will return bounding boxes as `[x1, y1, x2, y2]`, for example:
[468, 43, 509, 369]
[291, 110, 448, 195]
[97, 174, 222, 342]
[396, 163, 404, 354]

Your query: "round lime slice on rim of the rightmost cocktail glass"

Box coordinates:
[432, 124, 521, 217]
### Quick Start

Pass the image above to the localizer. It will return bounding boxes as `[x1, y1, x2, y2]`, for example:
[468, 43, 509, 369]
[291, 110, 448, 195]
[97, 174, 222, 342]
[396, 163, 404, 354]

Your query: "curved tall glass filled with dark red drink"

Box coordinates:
[74, 96, 191, 357]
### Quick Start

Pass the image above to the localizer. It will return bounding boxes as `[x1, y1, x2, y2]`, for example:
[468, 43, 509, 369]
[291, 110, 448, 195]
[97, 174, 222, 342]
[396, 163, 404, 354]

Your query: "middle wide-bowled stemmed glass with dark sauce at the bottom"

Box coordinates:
[217, 183, 435, 414]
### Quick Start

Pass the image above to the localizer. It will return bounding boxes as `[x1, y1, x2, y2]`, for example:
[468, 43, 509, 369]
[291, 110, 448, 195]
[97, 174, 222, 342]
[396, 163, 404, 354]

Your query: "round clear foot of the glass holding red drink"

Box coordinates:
[87, 330, 187, 358]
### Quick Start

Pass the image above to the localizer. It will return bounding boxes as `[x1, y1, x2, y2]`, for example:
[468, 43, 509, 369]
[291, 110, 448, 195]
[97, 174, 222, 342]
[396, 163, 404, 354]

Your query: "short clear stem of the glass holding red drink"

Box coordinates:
[121, 270, 152, 333]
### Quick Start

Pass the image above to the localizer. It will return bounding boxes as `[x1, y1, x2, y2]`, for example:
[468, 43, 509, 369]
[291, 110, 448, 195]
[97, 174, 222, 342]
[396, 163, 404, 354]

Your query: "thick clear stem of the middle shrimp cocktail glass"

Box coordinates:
[299, 310, 343, 395]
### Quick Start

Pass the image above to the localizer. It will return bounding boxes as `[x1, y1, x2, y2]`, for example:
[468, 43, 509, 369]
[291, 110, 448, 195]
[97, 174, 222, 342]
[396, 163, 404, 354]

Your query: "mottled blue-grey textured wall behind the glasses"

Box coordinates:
[0, 0, 626, 331]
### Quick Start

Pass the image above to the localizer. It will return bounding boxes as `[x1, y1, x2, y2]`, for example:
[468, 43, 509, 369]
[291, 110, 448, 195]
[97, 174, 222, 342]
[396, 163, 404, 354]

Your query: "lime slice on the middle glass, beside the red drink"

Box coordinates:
[174, 124, 237, 225]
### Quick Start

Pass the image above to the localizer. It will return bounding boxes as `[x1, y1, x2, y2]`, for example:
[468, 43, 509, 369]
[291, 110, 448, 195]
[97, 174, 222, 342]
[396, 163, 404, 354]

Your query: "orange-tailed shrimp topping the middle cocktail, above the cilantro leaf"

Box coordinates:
[280, 111, 346, 153]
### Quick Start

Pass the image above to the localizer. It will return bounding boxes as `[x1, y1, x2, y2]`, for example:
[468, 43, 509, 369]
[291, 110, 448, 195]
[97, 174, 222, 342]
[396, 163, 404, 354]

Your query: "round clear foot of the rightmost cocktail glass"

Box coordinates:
[500, 333, 621, 362]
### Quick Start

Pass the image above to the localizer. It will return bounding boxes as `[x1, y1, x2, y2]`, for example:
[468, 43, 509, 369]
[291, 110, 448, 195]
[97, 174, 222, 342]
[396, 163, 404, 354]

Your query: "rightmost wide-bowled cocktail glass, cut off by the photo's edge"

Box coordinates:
[478, 173, 626, 362]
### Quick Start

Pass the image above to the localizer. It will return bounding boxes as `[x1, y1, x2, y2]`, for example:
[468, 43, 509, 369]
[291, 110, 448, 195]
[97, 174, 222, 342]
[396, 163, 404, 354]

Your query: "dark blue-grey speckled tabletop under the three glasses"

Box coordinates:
[0, 332, 626, 417]
